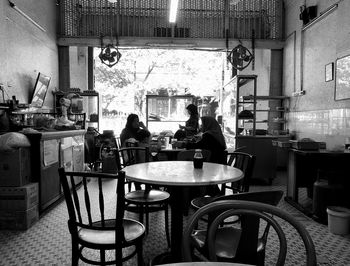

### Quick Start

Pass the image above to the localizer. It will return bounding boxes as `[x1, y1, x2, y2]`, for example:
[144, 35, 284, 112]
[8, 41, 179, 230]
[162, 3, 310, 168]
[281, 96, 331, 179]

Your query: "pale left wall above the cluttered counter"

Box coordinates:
[0, 0, 58, 108]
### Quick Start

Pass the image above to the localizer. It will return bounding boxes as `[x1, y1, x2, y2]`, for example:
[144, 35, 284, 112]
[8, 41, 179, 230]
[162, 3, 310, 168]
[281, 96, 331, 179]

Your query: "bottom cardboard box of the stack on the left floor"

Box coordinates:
[0, 205, 39, 230]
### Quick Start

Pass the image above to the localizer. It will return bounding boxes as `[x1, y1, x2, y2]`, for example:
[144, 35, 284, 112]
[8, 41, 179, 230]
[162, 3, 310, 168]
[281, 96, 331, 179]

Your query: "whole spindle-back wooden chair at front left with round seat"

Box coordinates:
[58, 168, 145, 265]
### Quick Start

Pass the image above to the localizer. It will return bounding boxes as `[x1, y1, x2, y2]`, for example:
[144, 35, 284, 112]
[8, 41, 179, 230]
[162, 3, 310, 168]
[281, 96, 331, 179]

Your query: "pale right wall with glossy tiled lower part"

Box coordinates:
[283, 0, 350, 147]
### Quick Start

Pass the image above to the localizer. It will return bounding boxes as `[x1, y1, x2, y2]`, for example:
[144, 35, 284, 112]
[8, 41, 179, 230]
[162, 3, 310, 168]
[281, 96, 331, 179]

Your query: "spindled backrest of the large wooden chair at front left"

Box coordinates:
[58, 167, 125, 261]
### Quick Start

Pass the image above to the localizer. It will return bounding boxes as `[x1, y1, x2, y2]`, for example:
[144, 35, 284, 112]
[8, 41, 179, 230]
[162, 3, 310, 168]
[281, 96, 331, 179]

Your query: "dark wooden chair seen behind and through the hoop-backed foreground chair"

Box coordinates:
[189, 190, 283, 265]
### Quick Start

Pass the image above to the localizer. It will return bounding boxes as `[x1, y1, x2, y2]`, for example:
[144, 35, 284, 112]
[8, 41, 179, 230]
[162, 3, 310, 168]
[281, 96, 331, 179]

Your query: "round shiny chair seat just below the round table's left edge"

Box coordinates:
[125, 189, 170, 205]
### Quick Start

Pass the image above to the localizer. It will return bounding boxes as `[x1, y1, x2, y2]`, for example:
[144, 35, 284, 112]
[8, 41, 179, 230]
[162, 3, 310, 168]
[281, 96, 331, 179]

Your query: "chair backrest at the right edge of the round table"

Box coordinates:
[223, 151, 255, 194]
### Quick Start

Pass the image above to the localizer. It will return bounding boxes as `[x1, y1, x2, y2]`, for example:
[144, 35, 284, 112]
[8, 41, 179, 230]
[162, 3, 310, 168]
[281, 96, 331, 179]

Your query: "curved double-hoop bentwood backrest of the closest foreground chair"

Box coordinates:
[182, 200, 316, 266]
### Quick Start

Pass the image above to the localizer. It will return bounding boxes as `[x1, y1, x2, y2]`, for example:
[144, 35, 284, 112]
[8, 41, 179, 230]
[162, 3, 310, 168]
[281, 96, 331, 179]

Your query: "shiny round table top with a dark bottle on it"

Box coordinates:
[123, 161, 243, 186]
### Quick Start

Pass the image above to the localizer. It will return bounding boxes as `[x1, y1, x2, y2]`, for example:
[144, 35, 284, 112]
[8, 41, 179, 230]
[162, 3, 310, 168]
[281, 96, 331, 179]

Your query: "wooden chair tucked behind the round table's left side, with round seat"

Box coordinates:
[119, 147, 170, 246]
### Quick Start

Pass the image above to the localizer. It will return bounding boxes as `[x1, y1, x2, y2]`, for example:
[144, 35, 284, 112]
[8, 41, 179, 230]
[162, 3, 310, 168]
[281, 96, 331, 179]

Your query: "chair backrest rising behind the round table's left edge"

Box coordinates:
[118, 147, 149, 167]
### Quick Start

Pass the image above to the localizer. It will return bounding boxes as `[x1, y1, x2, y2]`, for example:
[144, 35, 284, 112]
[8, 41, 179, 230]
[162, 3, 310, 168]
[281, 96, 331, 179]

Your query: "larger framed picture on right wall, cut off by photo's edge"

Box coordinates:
[334, 55, 350, 100]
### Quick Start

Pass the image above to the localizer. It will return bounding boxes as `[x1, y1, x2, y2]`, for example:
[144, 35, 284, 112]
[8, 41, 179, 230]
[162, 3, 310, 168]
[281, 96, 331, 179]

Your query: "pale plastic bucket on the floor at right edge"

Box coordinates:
[327, 206, 350, 235]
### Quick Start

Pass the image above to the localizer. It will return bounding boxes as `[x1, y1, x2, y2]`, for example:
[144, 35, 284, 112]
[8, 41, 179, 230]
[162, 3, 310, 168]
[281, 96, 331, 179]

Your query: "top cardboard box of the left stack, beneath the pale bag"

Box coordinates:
[0, 148, 31, 187]
